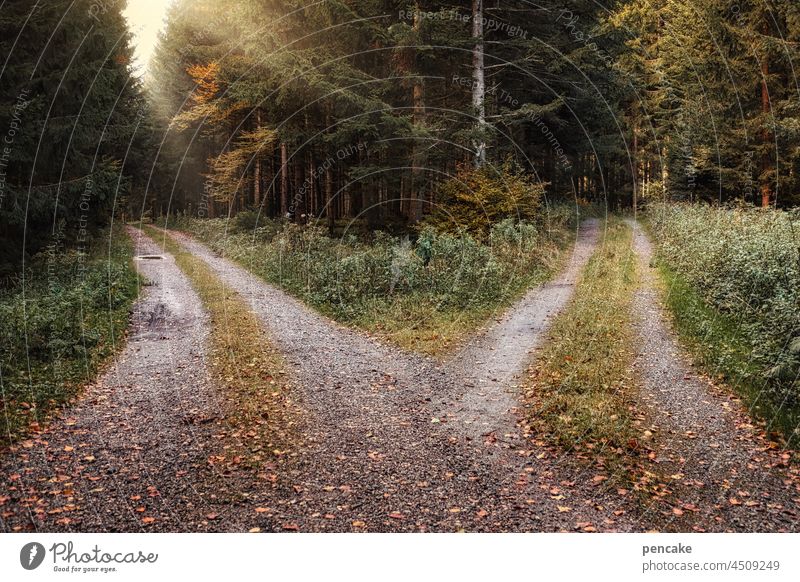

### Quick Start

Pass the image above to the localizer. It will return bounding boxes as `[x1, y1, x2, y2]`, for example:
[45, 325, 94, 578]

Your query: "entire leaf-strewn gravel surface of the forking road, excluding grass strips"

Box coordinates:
[0, 221, 800, 531]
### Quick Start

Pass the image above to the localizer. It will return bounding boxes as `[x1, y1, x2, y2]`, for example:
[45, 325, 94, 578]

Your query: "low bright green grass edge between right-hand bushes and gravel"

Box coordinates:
[657, 260, 800, 448]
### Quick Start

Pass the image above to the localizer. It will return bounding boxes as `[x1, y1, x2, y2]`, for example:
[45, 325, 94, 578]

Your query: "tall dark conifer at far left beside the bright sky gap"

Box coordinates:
[0, 0, 148, 268]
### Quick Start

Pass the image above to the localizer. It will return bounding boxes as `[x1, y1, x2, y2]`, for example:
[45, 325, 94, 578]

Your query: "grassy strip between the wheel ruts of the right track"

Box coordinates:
[526, 217, 638, 466]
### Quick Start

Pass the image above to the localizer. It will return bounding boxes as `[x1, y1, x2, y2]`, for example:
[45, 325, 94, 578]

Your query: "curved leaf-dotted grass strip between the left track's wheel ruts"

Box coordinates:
[143, 226, 295, 467]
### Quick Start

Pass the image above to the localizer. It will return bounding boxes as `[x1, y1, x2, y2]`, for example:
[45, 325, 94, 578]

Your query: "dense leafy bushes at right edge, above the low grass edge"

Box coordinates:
[649, 204, 800, 406]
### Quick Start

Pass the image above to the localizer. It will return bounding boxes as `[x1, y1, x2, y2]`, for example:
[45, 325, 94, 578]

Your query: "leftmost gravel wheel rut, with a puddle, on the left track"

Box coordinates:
[0, 228, 250, 531]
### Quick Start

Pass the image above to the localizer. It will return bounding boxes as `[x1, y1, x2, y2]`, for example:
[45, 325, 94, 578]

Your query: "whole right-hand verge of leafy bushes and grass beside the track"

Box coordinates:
[649, 204, 800, 436]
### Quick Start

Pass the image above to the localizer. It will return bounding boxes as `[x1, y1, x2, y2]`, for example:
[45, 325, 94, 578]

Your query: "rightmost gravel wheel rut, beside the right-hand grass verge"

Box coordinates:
[629, 220, 800, 531]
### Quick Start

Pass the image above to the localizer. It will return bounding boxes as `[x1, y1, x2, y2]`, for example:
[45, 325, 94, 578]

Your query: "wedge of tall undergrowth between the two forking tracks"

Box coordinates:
[170, 210, 574, 353]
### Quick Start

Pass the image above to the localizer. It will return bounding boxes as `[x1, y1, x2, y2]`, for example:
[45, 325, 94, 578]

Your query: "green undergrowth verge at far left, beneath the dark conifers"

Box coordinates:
[0, 227, 139, 445]
